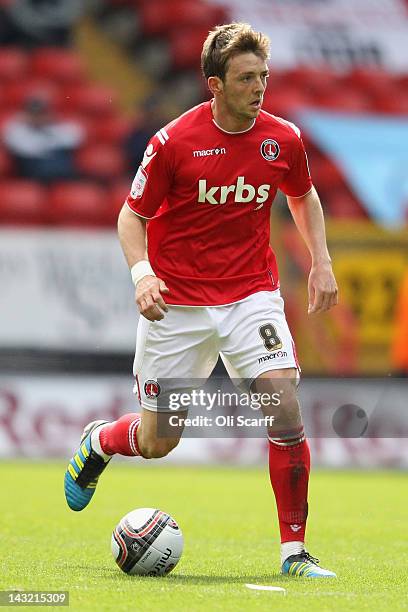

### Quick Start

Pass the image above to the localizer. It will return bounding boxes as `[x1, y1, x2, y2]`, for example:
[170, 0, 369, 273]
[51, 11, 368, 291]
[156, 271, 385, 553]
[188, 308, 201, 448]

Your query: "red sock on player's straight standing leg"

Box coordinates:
[269, 439, 310, 542]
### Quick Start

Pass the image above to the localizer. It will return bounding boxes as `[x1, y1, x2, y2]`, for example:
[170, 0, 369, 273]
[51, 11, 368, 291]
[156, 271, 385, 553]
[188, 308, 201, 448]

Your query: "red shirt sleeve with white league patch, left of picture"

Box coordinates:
[126, 130, 172, 219]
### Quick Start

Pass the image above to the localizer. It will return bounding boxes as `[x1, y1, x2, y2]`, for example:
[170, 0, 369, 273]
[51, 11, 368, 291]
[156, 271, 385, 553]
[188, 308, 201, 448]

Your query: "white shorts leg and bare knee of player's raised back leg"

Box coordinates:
[129, 306, 218, 458]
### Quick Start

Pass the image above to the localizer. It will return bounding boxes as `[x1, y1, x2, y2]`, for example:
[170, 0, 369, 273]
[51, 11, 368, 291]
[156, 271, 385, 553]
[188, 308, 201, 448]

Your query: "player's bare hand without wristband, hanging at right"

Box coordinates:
[308, 262, 338, 314]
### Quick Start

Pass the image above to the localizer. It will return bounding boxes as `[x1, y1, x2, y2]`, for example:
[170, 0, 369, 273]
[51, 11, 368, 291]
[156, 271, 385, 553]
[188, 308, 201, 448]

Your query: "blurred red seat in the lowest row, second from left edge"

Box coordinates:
[49, 181, 112, 227]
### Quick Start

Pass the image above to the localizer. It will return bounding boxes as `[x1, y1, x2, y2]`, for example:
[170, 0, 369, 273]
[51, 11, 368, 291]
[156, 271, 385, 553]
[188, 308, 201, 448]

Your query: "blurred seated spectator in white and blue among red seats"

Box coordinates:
[2, 96, 84, 183]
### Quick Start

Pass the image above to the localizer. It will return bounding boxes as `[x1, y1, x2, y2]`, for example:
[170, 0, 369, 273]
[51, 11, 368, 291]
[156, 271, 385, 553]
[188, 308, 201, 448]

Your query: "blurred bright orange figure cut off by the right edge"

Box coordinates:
[392, 270, 408, 376]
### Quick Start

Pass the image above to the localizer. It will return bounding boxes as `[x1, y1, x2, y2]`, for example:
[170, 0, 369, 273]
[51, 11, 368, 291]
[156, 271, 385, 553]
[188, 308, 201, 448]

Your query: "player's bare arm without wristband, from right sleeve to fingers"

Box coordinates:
[287, 187, 338, 314]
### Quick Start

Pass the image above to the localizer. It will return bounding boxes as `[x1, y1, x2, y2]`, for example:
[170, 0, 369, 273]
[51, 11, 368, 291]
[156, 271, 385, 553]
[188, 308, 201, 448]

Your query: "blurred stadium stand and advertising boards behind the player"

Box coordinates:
[0, 0, 408, 467]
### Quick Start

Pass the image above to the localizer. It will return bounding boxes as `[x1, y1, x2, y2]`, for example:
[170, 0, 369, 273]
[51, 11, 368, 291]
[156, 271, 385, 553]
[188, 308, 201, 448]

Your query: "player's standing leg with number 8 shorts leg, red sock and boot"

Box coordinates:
[221, 292, 335, 577]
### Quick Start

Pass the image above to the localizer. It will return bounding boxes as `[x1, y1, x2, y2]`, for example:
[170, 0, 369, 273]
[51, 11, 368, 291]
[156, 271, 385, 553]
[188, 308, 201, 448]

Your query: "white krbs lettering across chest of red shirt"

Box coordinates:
[198, 176, 271, 204]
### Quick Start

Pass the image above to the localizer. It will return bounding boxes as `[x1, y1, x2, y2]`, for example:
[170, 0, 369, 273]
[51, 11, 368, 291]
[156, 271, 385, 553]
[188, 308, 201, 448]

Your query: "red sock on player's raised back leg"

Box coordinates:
[99, 413, 141, 457]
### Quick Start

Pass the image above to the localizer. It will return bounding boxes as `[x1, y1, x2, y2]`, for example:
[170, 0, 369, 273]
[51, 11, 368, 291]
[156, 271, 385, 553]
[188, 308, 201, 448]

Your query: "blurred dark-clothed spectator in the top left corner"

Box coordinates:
[0, 0, 83, 48]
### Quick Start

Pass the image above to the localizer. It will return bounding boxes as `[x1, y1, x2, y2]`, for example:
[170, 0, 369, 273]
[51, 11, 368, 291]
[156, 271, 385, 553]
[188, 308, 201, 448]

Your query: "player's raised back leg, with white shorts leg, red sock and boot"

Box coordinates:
[65, 307, 218, 510]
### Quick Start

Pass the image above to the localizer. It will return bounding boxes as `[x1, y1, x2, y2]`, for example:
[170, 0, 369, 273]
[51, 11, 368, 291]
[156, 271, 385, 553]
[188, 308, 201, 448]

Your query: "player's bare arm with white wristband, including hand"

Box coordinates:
[118, 204, 169, 321]
